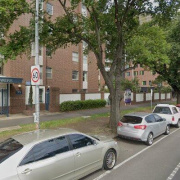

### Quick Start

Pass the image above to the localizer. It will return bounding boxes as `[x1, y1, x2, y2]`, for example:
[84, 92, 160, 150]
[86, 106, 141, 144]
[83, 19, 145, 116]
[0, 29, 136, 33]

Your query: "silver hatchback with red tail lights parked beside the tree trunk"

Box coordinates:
[117, 112, 170, 145]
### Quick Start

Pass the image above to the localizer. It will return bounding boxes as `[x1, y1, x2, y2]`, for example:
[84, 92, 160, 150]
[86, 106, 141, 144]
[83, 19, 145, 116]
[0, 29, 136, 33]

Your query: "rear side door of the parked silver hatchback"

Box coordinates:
[145, 114, 159, 137]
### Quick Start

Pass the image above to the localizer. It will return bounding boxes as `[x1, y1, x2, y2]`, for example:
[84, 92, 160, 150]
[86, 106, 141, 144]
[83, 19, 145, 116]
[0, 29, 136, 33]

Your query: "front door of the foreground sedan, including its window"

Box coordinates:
[69, 134, 102, 179]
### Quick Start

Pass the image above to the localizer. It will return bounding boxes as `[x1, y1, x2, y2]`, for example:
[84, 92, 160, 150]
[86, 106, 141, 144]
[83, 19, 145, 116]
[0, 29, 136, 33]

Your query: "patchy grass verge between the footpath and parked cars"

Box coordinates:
[0, 107, 151, 141]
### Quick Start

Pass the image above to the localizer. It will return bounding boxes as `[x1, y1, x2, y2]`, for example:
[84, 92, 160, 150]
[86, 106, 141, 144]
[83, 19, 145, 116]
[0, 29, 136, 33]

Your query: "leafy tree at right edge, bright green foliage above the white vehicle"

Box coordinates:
[127, 16, 180, 103]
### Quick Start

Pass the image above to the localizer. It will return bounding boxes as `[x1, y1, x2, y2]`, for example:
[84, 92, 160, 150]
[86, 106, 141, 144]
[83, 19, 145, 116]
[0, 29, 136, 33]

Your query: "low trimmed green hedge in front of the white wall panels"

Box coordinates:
[60, 99, 106, 111]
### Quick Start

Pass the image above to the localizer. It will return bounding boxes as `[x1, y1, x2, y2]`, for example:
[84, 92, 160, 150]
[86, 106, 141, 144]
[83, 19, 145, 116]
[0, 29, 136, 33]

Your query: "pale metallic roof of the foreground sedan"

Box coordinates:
[12, 128, 79, 145]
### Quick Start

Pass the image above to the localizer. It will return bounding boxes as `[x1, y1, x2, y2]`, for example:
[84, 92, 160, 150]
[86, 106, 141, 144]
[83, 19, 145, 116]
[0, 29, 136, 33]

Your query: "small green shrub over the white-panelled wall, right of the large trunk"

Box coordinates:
[121, 78, 140, 92]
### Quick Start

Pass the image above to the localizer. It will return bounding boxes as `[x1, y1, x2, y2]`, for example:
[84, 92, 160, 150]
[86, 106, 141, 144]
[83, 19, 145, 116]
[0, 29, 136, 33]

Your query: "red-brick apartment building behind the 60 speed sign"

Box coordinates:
[0, 0, 104, 114]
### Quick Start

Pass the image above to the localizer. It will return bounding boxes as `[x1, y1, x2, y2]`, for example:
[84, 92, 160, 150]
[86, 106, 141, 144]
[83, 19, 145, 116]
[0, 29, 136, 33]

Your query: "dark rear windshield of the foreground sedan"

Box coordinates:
[0, 139, 23, 163]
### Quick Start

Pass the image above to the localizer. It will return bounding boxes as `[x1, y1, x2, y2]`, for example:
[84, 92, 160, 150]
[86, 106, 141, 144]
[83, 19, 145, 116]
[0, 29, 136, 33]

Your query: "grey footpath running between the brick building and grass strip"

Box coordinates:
[0, 101, 172, 131]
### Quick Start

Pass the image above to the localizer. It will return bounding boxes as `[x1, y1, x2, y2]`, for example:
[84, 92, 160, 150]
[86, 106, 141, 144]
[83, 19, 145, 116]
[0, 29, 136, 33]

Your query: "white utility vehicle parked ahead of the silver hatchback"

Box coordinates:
[153, 104, 180, 128]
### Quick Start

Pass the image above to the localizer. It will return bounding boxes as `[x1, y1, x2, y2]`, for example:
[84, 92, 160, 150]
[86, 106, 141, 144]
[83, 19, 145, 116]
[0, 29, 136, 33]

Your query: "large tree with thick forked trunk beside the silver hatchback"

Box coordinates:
[3, 0, 179, 132]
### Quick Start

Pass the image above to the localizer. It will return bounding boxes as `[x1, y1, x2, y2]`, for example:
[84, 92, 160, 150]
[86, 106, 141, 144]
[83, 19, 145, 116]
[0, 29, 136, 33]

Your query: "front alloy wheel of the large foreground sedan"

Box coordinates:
[103, 149, 116, 170]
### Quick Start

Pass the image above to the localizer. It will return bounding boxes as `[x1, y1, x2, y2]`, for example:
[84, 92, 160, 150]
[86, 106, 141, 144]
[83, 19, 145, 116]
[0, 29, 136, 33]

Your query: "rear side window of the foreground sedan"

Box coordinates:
[20, 136, 69, 166]
